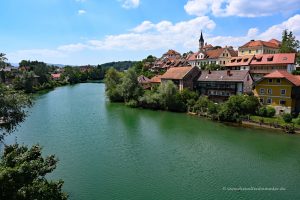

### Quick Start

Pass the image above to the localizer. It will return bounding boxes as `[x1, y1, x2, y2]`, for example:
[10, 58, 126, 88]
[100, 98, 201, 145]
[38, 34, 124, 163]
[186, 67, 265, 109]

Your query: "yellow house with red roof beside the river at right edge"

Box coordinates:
[253, 70, 300, 114]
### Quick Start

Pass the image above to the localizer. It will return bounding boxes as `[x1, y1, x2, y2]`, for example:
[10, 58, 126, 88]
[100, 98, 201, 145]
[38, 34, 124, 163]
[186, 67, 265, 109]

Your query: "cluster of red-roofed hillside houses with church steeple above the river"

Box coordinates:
[138, 32, 300, 114]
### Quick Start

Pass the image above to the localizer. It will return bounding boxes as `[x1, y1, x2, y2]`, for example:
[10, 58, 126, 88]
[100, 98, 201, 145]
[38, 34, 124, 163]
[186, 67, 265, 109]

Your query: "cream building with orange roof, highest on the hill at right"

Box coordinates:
[238, 39, 281, 56]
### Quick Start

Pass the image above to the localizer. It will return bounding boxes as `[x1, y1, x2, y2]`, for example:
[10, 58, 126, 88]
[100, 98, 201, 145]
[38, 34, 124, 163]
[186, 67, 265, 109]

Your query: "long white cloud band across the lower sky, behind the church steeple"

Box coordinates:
[7, 14, 300, 62]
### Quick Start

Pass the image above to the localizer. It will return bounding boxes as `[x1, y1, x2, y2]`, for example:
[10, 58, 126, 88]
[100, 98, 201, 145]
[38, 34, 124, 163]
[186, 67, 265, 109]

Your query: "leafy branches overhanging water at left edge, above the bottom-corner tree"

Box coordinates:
[0, 84, 31, 141]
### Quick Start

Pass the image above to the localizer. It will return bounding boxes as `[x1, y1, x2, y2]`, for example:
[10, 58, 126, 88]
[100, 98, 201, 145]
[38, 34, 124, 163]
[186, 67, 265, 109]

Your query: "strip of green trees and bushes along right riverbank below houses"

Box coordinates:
[105, 65, 300, 133]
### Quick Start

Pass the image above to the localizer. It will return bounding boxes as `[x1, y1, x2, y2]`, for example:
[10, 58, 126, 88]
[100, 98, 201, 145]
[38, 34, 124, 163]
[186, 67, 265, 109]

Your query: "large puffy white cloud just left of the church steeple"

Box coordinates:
[88, 16, 216, 50]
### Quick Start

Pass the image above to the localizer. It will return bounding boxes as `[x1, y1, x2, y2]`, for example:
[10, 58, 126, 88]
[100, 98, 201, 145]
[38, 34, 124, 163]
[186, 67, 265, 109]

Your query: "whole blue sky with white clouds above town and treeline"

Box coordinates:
[0, 0, 300, 65]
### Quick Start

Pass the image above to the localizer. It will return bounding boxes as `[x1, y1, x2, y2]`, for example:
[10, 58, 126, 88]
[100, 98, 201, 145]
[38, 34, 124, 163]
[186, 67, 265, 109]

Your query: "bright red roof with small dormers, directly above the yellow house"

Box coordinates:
[251, 53, 296, 65]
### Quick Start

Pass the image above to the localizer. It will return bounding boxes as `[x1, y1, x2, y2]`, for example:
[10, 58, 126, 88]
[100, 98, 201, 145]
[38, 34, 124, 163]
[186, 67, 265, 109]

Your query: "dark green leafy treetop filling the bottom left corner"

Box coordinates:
[0, 144, 67, 200]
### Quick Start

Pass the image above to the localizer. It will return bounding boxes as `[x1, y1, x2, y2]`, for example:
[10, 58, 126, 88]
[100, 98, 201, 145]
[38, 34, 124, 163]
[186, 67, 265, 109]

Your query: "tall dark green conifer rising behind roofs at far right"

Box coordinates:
[280, 29, 300, 53]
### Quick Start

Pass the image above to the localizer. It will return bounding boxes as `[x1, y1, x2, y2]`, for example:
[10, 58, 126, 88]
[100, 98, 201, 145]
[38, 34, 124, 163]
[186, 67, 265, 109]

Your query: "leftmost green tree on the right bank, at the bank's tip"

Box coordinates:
[104, 68, 124, 102]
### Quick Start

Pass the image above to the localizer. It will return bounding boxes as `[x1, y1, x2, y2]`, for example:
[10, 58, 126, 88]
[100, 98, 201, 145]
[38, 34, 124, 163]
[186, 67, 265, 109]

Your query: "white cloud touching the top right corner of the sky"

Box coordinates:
[184, 0, 300, 17]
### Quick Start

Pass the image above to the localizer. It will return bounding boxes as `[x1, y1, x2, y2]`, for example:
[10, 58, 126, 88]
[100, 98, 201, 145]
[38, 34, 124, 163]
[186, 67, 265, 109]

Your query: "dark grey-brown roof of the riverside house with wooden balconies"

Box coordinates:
[198, 70, 249, 82]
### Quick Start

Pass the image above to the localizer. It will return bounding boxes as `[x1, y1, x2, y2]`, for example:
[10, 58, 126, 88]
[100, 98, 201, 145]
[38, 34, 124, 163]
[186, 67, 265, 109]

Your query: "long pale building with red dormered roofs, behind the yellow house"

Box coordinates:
[225, 53, 296, 81]
